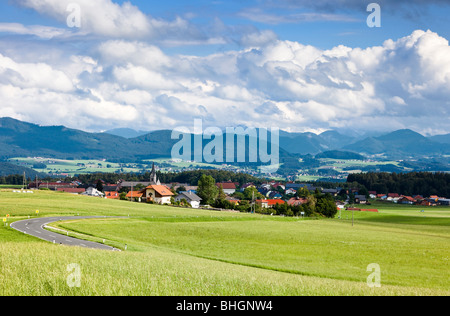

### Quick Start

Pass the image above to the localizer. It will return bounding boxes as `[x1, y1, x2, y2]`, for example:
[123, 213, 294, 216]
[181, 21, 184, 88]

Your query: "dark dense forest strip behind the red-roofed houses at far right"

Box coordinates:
[347, 172, 450, 197]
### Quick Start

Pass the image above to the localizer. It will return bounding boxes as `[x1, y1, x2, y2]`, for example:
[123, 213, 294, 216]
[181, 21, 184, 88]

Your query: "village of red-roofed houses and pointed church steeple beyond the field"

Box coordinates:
[24, 165, 450, 211]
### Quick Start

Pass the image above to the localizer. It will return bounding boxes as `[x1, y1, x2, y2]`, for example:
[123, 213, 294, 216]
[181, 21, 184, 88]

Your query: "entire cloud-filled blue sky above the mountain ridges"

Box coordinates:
[0, 0, 450, 135]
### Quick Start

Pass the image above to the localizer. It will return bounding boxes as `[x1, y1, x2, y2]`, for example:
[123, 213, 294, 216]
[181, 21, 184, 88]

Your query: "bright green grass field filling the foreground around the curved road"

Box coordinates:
[0, 190, 450, 296]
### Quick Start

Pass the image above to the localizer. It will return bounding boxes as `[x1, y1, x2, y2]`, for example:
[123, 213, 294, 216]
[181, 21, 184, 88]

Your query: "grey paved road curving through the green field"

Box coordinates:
[11, 216, 120, 251]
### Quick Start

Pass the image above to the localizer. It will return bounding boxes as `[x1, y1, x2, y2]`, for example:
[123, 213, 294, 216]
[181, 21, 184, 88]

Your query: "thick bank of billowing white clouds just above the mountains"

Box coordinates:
[0, 27, 450, 133]
